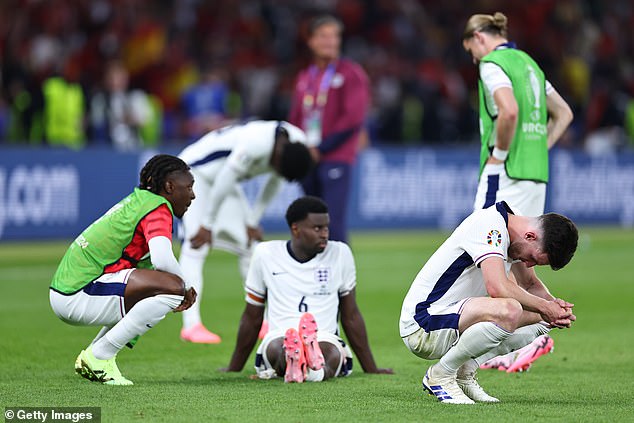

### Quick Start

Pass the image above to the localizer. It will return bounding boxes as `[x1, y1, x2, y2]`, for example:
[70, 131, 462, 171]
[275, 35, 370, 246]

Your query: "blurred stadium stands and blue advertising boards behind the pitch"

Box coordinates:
[0, 0, 634, 240]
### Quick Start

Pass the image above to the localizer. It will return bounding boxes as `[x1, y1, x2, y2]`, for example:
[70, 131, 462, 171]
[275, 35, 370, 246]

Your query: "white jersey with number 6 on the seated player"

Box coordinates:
[245, 241, 356, 334]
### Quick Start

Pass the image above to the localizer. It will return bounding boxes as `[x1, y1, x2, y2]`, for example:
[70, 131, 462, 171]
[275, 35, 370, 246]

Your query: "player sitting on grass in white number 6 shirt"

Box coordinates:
[224, 196, 392, 383]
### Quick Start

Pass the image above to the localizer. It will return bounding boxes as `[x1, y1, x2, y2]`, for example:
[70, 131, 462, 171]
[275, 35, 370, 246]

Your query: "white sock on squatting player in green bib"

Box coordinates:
[92, 294, 184, 360]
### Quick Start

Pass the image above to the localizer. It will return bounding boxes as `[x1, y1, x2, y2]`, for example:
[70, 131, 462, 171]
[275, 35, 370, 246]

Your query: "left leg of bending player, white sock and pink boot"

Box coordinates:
[179, 177, 221, 344]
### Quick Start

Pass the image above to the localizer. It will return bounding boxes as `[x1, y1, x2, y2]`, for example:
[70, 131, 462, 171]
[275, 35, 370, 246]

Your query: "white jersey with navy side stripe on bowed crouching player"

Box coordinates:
[399, 202, 513, 337]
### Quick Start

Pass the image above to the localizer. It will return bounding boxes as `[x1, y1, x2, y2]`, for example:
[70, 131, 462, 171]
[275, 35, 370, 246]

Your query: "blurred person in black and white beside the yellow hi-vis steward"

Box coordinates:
[90, 61, 152, 150]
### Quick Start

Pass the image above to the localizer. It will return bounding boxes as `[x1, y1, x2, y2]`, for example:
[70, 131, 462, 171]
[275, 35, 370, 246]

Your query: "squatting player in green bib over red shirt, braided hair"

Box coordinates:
[50, 154, 196, 385]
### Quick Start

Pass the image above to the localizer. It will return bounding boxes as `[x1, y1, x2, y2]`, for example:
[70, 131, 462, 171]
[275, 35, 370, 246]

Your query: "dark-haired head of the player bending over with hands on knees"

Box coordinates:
[271, 124, 314, 181]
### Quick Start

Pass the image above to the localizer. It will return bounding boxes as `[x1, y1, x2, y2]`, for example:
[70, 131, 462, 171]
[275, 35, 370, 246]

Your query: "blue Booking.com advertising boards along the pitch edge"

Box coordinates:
[0, 148, 634, 240]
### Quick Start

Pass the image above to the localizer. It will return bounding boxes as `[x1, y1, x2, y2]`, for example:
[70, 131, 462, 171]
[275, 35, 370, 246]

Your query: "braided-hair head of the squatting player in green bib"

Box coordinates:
[139, 154, 196, 217]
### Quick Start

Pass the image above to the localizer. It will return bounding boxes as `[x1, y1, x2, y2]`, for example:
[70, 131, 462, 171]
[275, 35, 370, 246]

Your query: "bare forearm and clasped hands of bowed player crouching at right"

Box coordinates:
[480, 257, 572, 325]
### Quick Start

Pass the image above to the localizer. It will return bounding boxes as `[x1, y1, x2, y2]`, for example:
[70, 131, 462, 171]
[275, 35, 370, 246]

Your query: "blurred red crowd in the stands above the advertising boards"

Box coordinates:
[0, 0, 634, 151]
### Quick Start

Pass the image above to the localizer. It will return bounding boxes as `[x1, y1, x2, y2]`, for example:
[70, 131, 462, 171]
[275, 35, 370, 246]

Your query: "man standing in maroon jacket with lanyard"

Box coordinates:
[288, 16, 370, 242]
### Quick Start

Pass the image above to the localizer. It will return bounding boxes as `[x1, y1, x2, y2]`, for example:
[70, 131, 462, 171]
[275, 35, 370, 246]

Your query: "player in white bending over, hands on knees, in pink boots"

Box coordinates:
[180, 121, 313, 344]
